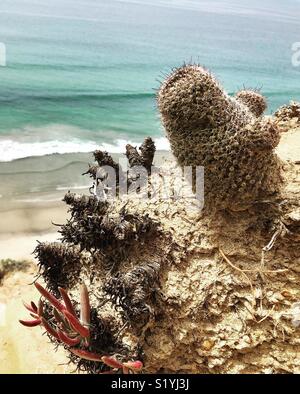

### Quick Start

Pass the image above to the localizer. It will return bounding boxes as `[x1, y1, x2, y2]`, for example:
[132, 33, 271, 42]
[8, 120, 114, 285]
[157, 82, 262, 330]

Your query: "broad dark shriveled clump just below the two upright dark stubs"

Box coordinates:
[59, 196, 159, 269]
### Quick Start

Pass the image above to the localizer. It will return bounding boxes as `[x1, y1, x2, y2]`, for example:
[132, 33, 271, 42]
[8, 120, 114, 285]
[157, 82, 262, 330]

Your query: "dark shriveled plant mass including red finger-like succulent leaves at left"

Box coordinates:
[20, 138, 162, 373]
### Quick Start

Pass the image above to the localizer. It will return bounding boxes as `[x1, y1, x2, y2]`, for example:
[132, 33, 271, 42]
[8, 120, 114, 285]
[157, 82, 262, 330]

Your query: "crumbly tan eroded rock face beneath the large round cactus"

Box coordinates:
[109, 146, 300, 373]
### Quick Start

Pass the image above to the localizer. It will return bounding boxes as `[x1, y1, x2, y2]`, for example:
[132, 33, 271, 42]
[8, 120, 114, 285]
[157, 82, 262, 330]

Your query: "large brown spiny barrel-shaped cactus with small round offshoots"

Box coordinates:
[158, 65, 282, 210]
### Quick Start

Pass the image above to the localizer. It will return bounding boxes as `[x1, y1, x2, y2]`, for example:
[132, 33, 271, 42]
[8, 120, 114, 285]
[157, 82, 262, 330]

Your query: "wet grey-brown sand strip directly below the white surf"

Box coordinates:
[0, 151, 172, 208]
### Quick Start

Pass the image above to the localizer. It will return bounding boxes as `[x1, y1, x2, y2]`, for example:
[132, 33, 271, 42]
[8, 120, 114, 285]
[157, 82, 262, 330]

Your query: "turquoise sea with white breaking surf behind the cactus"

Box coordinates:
[0, 0, 300, 161]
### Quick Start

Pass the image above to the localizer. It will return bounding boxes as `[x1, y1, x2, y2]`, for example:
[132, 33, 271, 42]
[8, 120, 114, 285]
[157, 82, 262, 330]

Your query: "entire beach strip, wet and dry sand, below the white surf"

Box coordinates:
[0, 151, 172, 260]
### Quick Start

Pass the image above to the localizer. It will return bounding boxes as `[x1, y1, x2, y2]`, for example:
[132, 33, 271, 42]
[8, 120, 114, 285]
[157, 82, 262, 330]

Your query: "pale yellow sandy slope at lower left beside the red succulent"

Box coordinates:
[0, 266, 74, 374]
